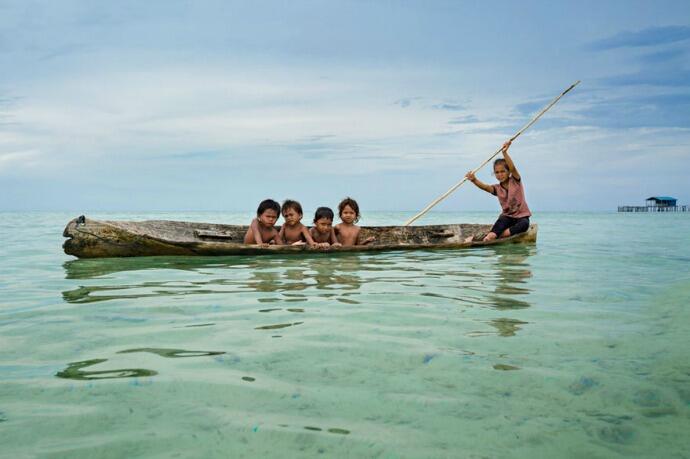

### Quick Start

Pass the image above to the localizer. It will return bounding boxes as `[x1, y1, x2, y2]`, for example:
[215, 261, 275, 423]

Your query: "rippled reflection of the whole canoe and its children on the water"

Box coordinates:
[62, 245, 536, 337]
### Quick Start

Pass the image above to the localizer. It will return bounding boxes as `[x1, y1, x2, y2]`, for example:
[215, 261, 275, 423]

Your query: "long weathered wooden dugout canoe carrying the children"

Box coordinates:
[63, 215, 537, 258]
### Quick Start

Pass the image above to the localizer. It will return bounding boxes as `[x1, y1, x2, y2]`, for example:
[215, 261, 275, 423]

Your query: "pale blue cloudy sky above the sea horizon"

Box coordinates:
[0, 0, 690, 213]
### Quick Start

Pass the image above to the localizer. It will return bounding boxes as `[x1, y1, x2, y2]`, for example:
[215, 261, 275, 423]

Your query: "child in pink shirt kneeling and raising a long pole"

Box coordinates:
[465, 140, 532, 242]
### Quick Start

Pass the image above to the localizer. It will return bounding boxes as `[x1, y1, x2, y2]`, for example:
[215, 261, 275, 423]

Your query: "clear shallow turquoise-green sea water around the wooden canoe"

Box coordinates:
[0, 213, 690, 458]
